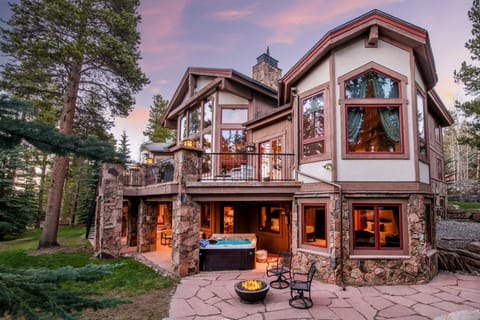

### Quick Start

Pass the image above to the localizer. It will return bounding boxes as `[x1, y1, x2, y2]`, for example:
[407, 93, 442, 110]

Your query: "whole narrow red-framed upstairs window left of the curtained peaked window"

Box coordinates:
[302, 91, 325, 158]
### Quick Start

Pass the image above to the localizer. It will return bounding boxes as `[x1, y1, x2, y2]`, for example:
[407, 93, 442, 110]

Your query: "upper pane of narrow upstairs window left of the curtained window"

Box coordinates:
[303, 92, 325, 140]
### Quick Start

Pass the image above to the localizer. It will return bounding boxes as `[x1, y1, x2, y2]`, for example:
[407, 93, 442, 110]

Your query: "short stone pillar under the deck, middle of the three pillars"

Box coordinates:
[137, 199, 157, 252]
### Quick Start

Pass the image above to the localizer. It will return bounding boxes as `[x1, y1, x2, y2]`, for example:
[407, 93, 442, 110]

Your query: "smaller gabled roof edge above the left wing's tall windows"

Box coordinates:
[160, 67, 277, 124]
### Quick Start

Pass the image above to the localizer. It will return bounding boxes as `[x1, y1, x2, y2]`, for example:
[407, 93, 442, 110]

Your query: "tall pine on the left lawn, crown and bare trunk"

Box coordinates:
[0, 0, 148, 248]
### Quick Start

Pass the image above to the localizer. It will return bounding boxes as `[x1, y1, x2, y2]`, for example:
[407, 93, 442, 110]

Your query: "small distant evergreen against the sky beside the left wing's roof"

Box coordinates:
[143, 95, 176, 142]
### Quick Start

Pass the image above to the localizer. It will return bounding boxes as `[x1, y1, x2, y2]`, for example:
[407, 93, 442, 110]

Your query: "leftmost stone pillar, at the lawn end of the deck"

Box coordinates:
[94, 163, 123, 258]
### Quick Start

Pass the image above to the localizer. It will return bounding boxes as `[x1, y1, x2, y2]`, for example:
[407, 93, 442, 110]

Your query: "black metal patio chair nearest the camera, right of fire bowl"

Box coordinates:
[288, 263, 317, 309]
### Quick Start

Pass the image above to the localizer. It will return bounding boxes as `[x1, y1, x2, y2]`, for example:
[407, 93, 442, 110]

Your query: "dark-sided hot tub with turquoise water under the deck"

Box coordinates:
[200, 239, 255, 271]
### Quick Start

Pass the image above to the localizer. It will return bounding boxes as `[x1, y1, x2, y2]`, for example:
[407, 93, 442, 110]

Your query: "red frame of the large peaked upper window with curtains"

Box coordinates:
[338, 62, 410, 159]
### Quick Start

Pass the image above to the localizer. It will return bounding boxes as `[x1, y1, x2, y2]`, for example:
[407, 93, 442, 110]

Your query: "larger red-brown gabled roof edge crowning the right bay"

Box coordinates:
[279, 10, 438, 104]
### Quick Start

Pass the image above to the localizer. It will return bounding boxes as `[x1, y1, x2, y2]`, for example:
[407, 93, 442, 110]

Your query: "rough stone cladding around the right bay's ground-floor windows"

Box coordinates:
[293, 195, 438, 286]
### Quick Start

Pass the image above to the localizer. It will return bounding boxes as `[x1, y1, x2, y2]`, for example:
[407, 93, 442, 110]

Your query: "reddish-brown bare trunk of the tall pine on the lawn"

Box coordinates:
[38, 61, 81, 249]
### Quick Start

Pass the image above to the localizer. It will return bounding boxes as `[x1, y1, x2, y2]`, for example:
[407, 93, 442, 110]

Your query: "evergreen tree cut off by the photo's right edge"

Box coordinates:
[454, 0, 480, 178]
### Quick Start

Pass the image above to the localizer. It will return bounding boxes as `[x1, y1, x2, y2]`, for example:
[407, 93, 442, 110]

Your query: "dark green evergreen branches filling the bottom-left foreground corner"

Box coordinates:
[0, 264, 127, 319]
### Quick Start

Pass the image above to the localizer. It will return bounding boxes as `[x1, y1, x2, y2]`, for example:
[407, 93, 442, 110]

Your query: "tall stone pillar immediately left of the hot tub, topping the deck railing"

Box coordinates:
[172, 147, 201, 276]
